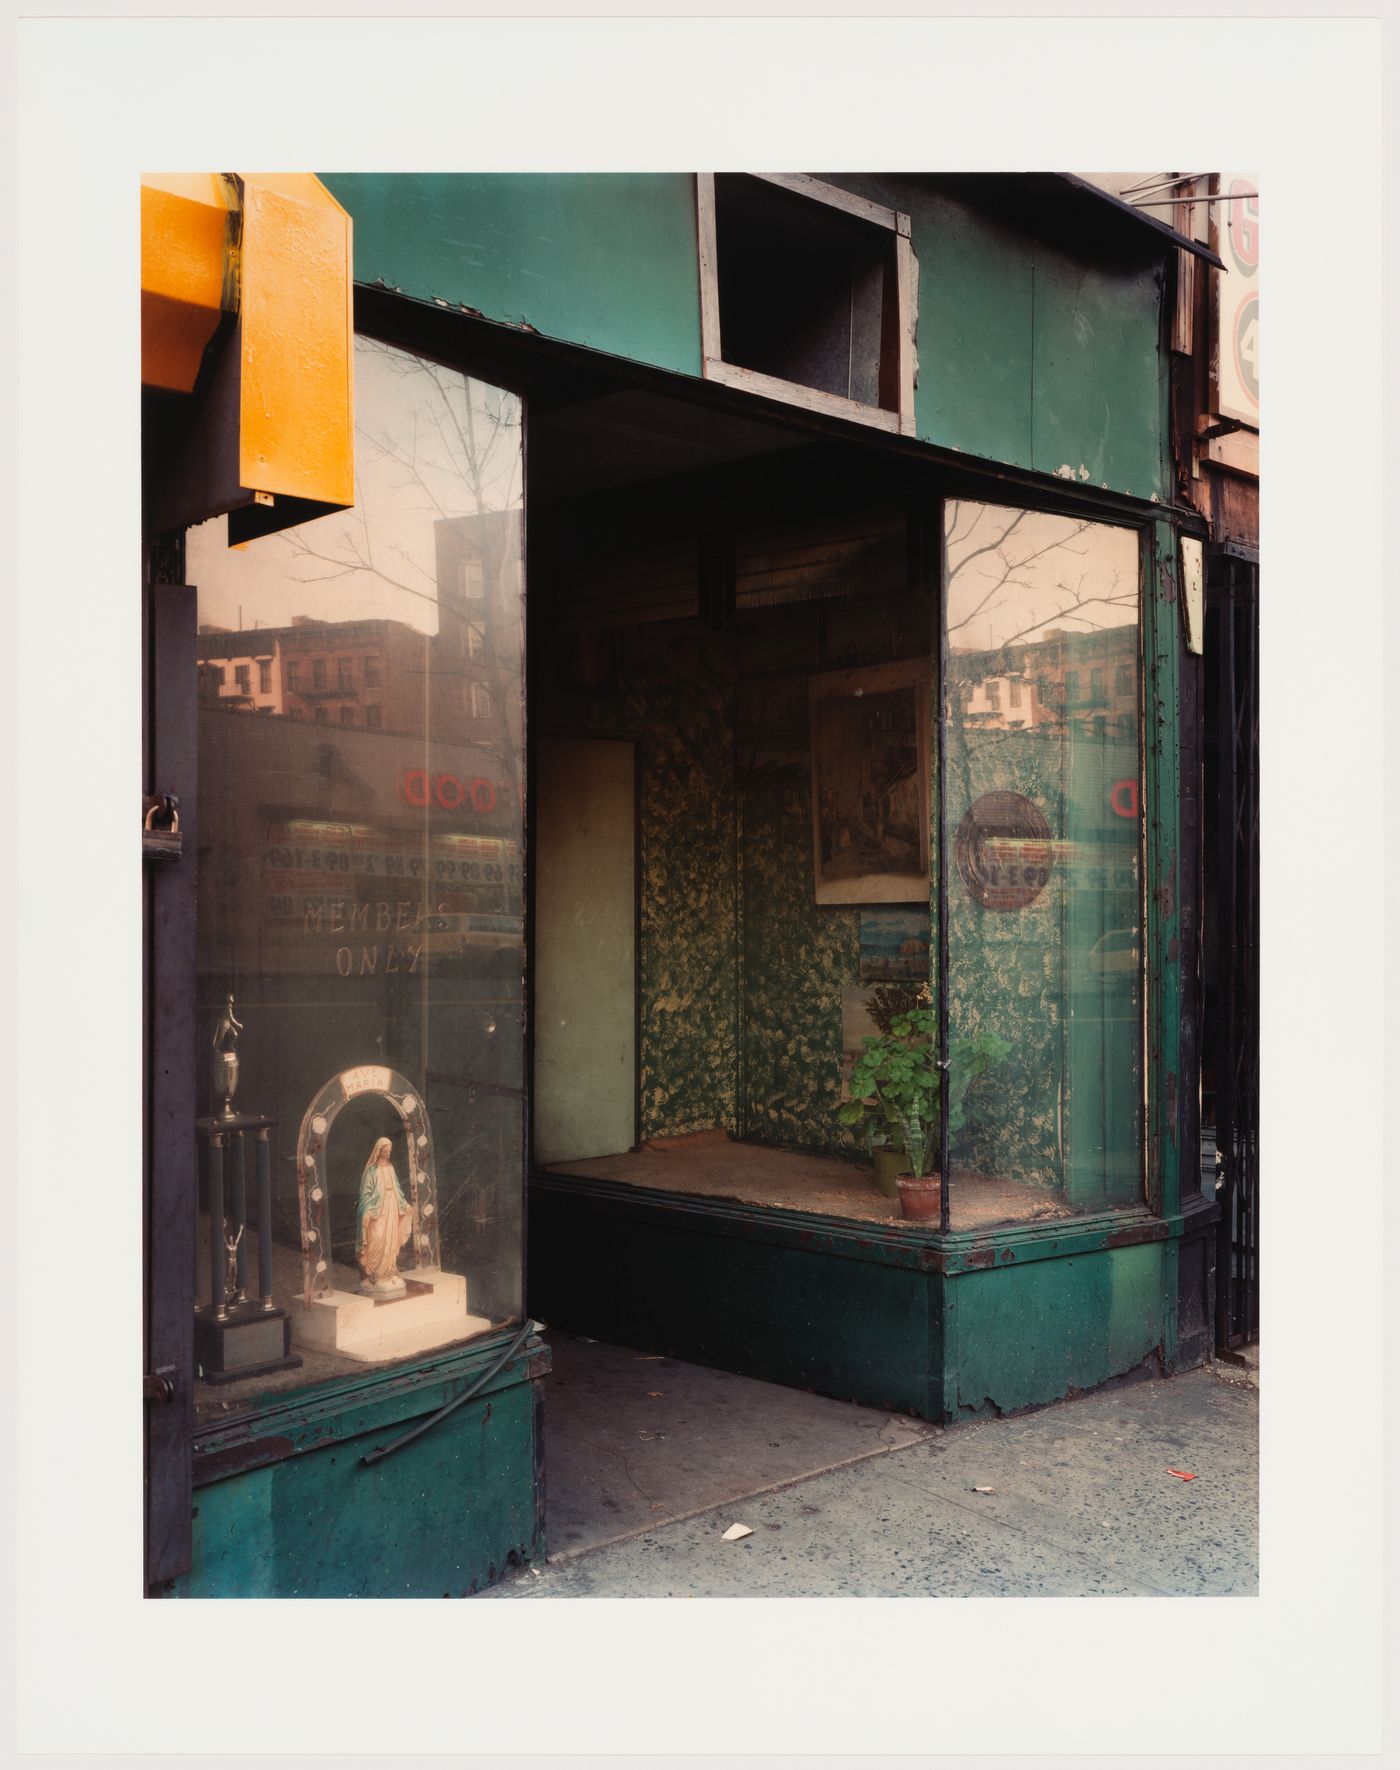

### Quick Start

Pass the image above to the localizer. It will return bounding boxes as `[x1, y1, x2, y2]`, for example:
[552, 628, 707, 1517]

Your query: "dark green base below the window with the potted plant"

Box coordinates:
[529, 1175, 1175, 1421]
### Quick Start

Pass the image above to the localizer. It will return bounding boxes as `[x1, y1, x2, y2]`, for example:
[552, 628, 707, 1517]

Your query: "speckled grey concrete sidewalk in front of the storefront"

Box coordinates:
[483, 1349, 1258, 1598]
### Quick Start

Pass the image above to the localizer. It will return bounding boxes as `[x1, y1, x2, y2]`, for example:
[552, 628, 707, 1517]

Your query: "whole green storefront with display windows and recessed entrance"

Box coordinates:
[147, 175, 1214, 1597]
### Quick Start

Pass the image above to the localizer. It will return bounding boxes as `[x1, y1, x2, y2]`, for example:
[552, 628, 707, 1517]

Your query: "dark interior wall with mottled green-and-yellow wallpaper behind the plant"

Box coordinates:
[533, 470, 931, 1156]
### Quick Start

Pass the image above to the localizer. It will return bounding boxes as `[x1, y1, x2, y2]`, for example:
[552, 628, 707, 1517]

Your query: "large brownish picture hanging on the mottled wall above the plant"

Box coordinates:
[809, 657, 931, 904]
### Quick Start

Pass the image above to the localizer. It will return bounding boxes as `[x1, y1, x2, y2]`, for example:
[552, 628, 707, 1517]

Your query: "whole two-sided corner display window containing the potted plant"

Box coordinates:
[533, 477, 1143, 1230]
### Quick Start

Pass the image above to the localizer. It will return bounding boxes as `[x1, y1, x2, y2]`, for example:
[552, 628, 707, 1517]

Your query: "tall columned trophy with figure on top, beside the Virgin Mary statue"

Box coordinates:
[195, 993, 301, 1382]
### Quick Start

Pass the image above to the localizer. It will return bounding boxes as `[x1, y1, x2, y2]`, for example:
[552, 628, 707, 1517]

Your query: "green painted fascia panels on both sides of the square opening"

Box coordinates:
[322, 173, 1166, 499]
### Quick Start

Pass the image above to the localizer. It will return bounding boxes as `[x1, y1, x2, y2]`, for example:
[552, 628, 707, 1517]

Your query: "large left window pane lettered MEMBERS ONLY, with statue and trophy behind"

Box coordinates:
[188, 338, 524, 1414]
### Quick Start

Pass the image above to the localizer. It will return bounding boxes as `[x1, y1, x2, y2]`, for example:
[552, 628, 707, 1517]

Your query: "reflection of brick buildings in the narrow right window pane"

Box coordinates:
[949, 627, 1138, 742]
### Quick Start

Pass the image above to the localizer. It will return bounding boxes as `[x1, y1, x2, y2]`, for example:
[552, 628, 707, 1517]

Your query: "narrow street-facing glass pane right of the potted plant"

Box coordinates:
[943, 501, 1143, 1228]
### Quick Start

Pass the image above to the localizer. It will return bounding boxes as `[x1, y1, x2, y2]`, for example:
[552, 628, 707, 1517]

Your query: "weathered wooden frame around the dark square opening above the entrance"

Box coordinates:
[696, 172, 919, 437]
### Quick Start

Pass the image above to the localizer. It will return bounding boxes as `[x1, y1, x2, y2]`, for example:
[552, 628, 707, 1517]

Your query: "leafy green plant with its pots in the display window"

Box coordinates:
[837, 991, 1011, 1218]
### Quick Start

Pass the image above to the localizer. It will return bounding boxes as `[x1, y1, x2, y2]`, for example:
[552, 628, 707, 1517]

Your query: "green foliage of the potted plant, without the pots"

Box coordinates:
[837, 1007, 1011, 1174]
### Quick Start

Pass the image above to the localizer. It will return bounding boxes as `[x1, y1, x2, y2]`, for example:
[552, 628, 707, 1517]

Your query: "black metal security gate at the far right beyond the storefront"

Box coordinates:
[1202, 545, 1258, 1352]
